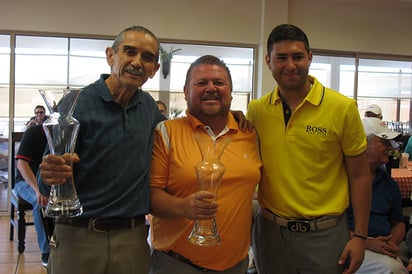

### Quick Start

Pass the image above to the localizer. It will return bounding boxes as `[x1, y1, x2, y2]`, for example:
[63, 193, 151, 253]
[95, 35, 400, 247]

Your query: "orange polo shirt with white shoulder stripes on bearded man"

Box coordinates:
[150, 113, 261, 271]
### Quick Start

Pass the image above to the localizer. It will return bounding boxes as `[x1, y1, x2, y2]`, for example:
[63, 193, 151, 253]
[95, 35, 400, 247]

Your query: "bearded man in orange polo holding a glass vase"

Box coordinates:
[150, 55, 261, 274]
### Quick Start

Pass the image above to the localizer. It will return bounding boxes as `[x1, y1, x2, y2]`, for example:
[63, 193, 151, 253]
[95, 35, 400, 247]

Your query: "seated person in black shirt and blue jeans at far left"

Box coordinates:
[13, 125, 49, 267]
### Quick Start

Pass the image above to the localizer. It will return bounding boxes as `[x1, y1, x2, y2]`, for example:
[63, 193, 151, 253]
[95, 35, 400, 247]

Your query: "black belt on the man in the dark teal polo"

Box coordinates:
[55, 216, 146, 232]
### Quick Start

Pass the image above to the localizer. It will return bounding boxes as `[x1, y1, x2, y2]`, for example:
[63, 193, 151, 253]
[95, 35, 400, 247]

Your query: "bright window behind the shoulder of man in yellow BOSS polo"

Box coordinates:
[310, 52, 412, 126]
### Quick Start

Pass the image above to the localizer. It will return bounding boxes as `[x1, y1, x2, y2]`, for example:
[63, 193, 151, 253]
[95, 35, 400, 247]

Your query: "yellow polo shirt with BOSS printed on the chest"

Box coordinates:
[247, 77, 366, 218]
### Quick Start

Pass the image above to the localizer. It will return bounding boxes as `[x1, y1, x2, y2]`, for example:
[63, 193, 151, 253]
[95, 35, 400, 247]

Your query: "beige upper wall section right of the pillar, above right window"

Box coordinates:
[289, 0, 412, 56]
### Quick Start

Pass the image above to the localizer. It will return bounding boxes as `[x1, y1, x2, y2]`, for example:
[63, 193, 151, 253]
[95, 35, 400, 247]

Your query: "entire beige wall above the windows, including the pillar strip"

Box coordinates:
[0, 0, 412, 96]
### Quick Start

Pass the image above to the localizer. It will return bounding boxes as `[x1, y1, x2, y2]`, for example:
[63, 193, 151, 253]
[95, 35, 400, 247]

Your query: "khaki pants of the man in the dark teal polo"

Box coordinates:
[48, 223, 150, 274]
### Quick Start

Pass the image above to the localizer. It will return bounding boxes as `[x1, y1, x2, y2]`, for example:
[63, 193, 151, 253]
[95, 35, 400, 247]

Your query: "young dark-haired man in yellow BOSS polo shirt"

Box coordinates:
[247, 24, 372, 274]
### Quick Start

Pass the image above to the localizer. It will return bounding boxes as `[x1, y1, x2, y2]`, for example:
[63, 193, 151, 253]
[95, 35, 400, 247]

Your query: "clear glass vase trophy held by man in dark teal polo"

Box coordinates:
[39, 89, 83, 218]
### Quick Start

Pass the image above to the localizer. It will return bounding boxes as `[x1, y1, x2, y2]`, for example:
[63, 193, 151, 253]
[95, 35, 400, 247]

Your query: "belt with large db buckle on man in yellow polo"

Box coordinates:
[260, 208, 342, 232]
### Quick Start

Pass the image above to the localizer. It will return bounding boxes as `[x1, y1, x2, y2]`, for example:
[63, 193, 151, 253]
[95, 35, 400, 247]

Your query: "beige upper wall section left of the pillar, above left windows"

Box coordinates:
[0, 0, 261, 44]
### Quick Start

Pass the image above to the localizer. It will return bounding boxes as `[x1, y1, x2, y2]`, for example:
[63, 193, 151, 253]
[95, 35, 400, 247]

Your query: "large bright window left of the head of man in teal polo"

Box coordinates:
[14, 35, 112, 131]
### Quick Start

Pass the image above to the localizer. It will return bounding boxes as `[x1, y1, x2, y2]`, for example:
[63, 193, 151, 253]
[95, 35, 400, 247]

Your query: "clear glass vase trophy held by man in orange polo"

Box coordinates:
[188, 134, 230, 246]
